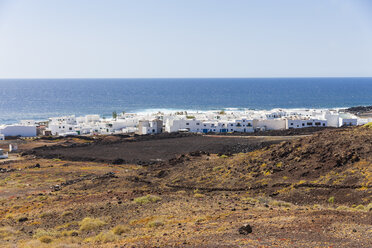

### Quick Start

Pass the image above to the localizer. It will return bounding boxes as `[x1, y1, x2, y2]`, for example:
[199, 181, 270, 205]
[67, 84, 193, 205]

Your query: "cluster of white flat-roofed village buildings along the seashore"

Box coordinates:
[0, 109, 372, 140]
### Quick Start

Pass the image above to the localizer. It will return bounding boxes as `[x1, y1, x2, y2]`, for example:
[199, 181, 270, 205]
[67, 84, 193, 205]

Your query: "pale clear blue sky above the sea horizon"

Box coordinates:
[0, 0, 372, 78]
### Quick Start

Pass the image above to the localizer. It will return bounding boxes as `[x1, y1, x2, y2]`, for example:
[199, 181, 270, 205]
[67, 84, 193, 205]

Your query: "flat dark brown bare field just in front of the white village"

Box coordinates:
[23, 134, 294, 164]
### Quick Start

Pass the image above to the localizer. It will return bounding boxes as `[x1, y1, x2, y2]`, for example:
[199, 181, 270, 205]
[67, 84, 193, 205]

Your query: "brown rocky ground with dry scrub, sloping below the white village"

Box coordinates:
[0, 125, 372, 247]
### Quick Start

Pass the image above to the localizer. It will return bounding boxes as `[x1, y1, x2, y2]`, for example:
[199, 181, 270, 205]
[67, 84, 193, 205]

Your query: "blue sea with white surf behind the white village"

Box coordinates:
[0, 78, 372, 123]
